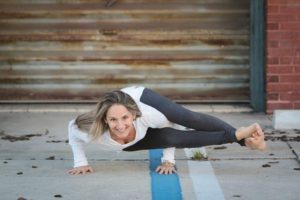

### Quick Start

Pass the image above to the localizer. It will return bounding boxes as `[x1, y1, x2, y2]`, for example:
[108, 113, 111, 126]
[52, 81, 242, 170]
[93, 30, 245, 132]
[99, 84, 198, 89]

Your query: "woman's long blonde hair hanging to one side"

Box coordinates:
[75, 91, 142, 139]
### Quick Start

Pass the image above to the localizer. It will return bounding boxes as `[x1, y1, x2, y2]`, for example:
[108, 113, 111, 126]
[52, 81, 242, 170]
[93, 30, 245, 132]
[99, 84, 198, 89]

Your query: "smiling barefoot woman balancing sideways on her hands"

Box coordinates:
[68, 86, 266, 175]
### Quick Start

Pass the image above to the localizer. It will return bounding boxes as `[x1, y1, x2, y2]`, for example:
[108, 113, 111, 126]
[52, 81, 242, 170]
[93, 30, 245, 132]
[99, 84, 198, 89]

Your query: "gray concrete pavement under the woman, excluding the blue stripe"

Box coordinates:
[0, 104, 300, 200]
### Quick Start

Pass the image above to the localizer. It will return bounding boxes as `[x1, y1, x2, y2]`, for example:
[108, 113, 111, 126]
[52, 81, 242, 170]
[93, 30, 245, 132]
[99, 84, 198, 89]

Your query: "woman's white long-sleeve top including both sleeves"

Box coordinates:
[68, 86, 178, 167]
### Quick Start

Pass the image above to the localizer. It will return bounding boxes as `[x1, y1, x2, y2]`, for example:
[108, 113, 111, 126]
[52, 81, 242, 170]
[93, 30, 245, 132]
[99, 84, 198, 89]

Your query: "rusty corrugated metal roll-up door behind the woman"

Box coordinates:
[0, 0, 250, 102]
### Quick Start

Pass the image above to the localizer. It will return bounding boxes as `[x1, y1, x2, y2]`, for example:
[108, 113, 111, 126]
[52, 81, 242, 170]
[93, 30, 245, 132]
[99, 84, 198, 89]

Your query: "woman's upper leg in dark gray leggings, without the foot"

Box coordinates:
[140, 88, 244, 145]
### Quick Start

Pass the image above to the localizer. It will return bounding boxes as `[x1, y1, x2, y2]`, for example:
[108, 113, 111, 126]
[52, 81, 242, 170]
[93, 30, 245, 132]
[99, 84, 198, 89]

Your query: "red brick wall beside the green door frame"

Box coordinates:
[266, 0, 300, 114]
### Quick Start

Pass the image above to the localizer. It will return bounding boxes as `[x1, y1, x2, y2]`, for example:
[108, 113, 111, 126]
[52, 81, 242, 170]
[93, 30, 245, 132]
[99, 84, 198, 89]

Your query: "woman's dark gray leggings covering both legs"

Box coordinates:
[123, 88, 245, 151]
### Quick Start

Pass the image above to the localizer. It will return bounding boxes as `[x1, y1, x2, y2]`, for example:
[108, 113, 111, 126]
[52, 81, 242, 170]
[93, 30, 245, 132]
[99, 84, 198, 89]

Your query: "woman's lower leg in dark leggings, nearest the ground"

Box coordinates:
[123, 128, 236, 151]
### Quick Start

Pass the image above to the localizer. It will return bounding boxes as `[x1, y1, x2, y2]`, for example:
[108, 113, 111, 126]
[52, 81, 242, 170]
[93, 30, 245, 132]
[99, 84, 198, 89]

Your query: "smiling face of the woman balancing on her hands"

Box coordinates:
[106, 104, 135, 139]
